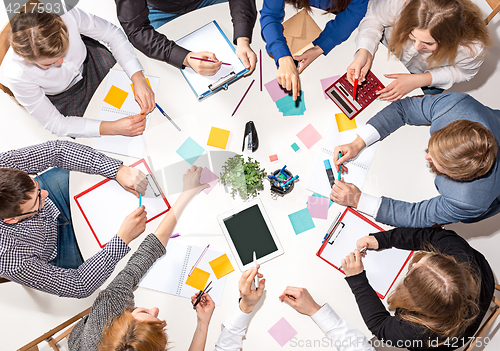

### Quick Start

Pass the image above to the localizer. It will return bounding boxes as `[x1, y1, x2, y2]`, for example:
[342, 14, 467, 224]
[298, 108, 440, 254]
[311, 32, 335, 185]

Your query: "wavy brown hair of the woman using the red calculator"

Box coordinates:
[389, 0, 492, 67]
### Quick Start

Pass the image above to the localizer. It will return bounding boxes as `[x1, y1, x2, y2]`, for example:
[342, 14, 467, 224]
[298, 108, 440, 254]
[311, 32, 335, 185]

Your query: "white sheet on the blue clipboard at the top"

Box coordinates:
[176, 21, 245, 96]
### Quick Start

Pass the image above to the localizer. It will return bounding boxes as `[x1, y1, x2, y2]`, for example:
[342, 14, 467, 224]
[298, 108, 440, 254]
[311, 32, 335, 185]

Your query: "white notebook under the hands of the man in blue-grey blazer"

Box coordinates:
[306, 119, 378, 197]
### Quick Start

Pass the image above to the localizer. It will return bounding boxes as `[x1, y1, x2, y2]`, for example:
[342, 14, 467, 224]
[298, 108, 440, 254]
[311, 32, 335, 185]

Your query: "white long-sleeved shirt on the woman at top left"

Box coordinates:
[2, 7, 143, 137]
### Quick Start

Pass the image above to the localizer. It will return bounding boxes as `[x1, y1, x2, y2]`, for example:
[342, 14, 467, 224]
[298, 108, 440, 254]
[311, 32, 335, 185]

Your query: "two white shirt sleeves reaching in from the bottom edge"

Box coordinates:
[215, 303, 375, 351]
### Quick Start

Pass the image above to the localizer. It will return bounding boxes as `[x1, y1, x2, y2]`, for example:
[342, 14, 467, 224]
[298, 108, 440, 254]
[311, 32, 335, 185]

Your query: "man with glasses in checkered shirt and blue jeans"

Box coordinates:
[0, 140, 147, 298]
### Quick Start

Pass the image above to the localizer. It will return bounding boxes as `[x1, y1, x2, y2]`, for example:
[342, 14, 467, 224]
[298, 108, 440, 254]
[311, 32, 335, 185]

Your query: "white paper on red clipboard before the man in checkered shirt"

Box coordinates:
[76, 162, 168, 245]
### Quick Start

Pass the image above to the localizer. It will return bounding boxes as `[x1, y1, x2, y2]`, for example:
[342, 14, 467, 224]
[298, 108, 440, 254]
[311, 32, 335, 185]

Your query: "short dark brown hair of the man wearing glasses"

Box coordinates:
[0, 168, 35, 219]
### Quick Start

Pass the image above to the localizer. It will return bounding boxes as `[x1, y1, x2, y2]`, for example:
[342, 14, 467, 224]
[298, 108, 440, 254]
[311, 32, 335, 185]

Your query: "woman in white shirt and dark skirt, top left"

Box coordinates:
[2, 7, 155, 137]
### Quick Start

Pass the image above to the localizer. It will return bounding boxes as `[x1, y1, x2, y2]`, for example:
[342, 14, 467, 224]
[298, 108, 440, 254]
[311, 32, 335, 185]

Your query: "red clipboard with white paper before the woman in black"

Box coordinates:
[316, 207, 413, 299]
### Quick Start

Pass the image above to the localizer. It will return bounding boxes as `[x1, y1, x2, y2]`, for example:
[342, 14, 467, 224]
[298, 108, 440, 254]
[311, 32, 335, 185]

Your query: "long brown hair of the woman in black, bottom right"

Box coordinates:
[387, 251, 480, 344]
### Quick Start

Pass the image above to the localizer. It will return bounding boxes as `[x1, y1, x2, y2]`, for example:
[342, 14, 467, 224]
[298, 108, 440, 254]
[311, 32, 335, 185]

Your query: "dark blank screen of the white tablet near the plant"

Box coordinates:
[224, 205, 278, 265]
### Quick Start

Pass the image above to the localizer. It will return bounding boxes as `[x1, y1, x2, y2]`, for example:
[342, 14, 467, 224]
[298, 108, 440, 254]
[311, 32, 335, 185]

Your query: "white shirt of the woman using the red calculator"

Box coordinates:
[356, 0, 485, 89]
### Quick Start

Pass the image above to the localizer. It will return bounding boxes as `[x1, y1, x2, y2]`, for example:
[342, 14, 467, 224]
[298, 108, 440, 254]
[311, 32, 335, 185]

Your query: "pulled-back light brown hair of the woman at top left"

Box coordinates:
[10, 11, 69, 63]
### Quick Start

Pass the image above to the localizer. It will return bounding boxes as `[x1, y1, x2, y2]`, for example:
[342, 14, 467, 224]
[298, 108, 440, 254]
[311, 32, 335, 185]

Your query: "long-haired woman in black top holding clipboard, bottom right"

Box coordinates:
[341, 228, 495, 350]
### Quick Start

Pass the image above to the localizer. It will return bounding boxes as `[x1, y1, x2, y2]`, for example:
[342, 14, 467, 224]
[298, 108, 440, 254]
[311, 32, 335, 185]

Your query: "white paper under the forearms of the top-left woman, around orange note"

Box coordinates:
[92, 69, 160, 158]
